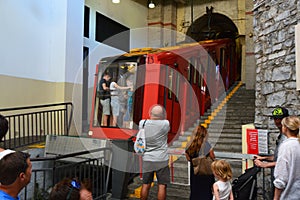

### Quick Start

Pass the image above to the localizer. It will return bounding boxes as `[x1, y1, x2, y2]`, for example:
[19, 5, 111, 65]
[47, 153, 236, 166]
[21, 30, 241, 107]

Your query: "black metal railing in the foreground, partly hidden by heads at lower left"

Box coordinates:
[20, 148, 112, 200]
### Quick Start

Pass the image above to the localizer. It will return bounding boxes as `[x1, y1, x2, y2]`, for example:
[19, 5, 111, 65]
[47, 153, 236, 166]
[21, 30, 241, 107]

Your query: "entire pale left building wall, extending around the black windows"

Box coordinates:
[0, 0, 148, 136]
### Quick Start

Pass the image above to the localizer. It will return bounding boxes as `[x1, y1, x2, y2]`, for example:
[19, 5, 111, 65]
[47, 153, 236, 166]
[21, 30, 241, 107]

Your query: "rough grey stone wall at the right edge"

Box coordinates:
[253, 0, 300, 197]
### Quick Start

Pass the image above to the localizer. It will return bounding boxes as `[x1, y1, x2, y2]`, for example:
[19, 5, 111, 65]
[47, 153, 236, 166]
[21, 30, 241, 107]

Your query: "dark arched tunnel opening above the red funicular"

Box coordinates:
[186, 7, 239, 41]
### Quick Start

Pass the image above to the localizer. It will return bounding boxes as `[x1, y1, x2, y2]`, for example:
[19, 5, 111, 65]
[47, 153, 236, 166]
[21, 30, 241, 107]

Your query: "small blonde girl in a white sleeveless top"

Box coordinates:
[211, 160, 233, 200]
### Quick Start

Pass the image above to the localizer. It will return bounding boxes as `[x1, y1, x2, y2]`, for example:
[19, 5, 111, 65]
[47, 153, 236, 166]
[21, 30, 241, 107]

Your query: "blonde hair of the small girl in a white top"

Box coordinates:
[211, 160, 232, 181]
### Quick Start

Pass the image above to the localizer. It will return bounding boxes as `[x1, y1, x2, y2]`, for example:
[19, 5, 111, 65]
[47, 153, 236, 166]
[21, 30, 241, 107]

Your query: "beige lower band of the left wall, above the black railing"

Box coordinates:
[0, 75, 81, 135]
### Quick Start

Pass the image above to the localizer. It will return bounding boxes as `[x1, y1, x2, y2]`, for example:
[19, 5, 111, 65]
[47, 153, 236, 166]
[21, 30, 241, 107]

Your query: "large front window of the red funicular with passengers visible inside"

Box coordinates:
[93, 61, 137, 129]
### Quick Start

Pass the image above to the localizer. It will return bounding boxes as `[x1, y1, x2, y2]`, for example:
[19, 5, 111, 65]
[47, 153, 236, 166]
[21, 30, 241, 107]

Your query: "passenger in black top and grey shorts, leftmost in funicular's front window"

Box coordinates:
[99, 72, 111, 126]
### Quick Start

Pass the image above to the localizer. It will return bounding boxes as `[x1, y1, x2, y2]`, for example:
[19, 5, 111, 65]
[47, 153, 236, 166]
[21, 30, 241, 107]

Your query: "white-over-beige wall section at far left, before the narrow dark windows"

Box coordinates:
[0, 0, 83, 108]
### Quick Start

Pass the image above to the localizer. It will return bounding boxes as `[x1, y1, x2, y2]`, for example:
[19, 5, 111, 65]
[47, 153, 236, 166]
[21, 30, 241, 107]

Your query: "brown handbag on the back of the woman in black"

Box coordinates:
[192, 145, 213, 175]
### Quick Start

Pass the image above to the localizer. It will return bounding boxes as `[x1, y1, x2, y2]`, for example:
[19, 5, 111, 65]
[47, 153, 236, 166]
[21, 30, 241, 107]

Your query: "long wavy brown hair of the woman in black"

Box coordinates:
[186, 125, 208, 156]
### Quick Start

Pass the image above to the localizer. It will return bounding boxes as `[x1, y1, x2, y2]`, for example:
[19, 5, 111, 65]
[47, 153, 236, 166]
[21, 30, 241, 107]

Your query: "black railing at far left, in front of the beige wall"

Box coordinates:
[0, 103, 73, 149]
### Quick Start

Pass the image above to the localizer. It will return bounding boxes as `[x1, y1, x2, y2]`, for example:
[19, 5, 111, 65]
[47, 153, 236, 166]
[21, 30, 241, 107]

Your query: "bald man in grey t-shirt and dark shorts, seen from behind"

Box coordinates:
[139, 105, 170, 200]
